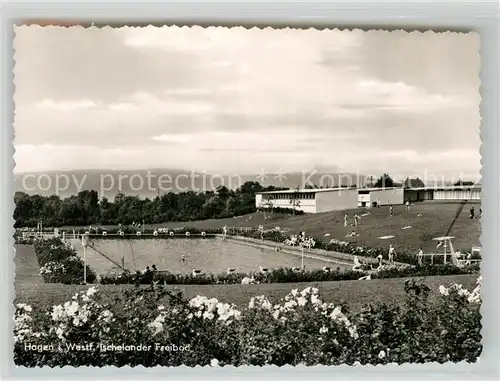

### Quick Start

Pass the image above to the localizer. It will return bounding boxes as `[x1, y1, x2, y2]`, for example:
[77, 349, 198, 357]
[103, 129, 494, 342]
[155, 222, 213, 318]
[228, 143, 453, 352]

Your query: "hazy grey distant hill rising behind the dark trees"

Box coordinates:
[14, 169, 365, 198]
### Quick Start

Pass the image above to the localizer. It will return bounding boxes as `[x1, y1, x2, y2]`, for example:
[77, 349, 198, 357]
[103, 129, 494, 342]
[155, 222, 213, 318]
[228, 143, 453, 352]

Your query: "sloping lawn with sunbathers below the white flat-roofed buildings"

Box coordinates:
[63, 202, 481, 253]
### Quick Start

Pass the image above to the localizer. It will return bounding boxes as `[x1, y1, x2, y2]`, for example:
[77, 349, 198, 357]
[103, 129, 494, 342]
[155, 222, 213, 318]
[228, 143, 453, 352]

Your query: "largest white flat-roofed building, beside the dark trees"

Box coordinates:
[255, 188, 358, 213]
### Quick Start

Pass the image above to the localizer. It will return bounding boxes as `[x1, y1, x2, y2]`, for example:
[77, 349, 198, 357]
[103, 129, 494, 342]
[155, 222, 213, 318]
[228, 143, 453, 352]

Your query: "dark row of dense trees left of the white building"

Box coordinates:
[14, 181, 287, 227]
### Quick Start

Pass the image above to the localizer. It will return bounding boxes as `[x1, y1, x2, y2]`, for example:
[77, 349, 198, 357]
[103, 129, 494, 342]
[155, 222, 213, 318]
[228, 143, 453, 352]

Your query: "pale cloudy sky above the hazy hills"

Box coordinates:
[14, 27, 481, 179]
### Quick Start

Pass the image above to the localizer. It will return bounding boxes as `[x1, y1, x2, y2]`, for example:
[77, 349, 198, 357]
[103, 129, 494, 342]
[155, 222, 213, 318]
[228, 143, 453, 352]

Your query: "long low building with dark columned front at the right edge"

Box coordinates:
[404, 185, 481, 202]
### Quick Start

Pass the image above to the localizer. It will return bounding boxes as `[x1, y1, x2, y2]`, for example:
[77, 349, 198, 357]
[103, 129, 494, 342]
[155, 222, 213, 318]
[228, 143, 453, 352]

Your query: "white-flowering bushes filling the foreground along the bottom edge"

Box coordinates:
[14, 281, 482, 366]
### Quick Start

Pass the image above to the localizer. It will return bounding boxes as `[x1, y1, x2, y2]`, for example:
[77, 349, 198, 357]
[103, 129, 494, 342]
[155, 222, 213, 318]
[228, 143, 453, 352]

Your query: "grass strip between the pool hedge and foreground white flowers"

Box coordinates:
[15, 275, 477, 310]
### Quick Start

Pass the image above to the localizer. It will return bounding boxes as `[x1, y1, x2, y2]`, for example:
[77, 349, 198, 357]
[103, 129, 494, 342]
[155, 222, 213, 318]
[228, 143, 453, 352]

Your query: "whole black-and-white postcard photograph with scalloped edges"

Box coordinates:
[9, 25, 483, 367]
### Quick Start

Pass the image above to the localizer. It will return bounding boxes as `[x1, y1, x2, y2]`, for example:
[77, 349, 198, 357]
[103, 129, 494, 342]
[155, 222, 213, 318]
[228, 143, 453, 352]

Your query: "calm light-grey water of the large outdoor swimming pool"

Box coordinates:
[73, 239, 333, 275]
